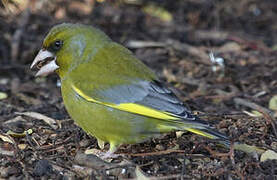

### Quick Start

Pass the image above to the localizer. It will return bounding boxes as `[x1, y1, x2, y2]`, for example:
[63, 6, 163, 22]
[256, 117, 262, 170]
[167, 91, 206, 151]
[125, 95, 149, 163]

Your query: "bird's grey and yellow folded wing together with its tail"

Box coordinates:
[72, 81, 229, 141]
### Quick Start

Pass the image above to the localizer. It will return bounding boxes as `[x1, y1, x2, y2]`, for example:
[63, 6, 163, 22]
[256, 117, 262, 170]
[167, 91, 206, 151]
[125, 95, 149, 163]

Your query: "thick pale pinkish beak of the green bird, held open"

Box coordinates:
[30, 49, 59, 77]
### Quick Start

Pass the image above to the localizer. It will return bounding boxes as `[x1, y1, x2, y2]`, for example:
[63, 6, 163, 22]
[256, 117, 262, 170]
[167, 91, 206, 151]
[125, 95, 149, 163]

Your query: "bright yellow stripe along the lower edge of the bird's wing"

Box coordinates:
[72, 85, 180, 120]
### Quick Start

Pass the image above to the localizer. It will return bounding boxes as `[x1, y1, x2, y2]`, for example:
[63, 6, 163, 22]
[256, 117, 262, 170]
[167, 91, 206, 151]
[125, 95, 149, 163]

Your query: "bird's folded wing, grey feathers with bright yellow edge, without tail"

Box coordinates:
[72, 80, 198, 121]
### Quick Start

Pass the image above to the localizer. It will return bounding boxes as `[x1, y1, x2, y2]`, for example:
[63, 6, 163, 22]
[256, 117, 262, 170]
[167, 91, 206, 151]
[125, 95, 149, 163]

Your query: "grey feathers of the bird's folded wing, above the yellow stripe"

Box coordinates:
[97, 81, 195, 120]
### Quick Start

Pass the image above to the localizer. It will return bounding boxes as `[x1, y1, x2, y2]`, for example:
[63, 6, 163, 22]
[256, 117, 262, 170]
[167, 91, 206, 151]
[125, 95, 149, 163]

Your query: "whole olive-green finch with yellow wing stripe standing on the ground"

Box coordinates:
[31, 23, 230, 157]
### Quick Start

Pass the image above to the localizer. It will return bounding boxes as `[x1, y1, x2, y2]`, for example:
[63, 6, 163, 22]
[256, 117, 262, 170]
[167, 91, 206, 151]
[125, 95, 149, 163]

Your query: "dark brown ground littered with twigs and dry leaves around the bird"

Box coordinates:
[0, 0, 277, 179]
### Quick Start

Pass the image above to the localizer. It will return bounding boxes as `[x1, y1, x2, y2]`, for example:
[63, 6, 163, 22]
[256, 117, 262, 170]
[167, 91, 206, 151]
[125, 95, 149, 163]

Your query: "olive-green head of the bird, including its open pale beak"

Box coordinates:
[31, 23, 110, 76]
